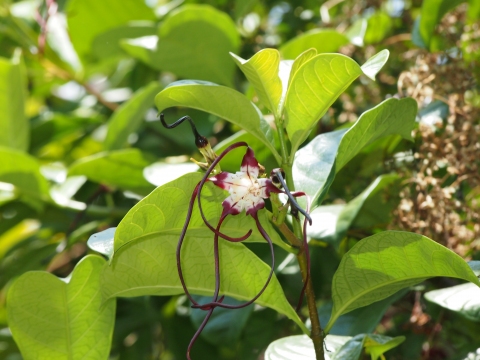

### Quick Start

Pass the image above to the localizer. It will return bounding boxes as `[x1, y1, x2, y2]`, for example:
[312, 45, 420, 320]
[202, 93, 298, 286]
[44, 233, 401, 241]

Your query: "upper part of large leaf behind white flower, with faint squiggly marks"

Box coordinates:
[114, 173, 285, 252]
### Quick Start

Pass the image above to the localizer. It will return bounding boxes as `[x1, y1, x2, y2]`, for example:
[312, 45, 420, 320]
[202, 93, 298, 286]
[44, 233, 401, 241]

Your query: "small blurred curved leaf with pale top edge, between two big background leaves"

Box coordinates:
[92, 21, 157, 59]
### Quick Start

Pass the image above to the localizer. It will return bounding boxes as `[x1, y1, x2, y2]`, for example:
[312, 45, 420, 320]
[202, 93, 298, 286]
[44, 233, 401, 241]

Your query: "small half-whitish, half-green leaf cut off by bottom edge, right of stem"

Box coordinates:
[332, 334, 405, 360]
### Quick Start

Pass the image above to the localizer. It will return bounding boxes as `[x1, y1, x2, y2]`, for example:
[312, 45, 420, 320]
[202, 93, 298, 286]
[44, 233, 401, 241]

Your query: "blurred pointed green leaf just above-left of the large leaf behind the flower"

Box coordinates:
[68, 149, 154, 195]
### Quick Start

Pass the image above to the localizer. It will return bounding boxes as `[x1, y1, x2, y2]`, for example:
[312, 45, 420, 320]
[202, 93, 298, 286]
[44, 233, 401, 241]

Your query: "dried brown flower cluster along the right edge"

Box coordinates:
[393, 8, 480, 257]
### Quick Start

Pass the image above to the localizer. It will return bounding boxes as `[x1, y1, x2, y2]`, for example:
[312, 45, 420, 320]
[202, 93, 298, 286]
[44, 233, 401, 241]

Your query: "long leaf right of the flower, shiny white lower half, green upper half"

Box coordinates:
[293, 98, 417, 207]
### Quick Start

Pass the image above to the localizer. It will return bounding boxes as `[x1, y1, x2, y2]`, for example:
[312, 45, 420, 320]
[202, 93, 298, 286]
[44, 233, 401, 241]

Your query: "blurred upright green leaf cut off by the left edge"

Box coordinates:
[0, 52, 30, 151]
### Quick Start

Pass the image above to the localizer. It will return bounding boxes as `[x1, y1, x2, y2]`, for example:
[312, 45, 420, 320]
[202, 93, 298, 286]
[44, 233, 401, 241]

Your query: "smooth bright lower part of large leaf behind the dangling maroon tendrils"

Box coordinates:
[102, 232, 308, 333]
